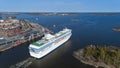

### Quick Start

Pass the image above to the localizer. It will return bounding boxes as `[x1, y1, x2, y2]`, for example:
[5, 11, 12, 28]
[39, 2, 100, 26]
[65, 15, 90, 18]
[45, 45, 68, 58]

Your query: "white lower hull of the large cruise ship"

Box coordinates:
[29, 34, 71, 59]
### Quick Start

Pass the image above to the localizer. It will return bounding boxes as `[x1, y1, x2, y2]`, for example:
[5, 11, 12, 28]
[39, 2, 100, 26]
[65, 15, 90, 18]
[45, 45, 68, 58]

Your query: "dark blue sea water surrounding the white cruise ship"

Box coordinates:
[0, 13, 120, 68]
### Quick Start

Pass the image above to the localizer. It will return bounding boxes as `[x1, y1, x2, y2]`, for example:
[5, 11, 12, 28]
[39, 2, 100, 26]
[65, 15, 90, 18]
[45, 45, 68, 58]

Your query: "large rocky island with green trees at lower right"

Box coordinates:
[73, 45, 120, 68]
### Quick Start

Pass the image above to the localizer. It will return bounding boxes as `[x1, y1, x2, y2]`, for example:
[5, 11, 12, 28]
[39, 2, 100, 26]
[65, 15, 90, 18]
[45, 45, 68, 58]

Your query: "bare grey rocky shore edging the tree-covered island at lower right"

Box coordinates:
[73, 45, 117, 68]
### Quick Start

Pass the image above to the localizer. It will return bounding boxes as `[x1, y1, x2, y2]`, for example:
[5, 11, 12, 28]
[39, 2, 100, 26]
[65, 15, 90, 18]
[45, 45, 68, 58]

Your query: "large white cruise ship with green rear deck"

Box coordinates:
[29, 28, 72, 59]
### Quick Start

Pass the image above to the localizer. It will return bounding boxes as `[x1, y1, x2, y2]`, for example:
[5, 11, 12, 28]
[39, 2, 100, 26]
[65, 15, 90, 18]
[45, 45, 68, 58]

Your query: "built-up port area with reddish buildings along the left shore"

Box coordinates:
[0, 17, 52, 52]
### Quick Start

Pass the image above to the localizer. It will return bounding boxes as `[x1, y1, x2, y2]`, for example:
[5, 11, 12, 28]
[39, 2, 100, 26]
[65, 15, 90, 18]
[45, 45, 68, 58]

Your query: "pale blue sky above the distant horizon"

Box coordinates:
[0, 0, 120, 12]
